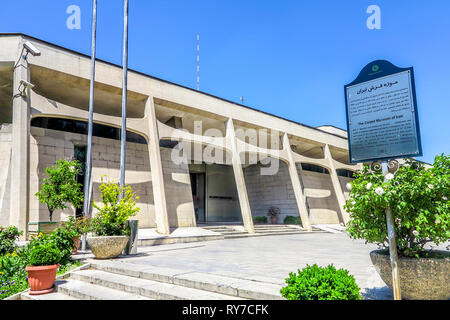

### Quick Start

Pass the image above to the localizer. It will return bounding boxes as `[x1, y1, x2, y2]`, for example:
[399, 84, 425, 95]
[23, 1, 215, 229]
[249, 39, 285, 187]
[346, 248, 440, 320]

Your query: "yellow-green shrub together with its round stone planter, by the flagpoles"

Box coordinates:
[87, 182, 139, 259]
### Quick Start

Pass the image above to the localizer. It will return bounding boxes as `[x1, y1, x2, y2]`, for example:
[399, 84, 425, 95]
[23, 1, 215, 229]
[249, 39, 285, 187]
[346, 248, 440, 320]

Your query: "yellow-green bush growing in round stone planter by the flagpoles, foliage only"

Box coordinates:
[90, 182, 139, 236]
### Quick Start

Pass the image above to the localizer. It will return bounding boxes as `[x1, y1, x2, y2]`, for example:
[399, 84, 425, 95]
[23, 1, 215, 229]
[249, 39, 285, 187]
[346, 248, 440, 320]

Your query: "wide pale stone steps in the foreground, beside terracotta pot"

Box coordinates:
[20, 259, 282, 300]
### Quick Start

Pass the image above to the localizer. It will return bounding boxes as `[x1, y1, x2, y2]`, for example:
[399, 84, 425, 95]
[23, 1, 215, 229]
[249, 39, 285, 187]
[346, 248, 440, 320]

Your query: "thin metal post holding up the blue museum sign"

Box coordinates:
[381, 161, 402, 300]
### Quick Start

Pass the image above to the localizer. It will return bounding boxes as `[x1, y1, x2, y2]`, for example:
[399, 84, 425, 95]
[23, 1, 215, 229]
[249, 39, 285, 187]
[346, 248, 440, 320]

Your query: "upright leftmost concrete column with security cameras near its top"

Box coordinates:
[9, 50, 31, 240]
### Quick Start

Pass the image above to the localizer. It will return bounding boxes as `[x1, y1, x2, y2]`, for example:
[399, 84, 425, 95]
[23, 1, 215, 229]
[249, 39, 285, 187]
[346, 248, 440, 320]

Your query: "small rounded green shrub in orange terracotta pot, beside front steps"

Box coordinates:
[25, 235, 62, 295]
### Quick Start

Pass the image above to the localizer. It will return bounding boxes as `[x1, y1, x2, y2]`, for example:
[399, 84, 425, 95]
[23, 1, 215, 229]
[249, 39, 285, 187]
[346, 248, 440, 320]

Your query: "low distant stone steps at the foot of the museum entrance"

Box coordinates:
[202, 224, 326, 239]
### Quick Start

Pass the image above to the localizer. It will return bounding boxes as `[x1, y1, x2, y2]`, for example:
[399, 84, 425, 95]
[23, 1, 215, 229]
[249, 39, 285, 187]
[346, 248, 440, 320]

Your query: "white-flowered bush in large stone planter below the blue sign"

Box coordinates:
[345, 155, 450, 300]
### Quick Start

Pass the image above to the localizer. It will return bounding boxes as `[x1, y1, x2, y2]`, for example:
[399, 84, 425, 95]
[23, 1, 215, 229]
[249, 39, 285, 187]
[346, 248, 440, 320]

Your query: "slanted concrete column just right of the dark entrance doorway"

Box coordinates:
[226, 119, 255, 233]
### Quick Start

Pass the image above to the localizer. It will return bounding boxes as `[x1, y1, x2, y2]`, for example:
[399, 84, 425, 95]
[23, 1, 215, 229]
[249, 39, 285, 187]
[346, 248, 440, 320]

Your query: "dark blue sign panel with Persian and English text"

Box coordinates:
[344, 60, 422, 163]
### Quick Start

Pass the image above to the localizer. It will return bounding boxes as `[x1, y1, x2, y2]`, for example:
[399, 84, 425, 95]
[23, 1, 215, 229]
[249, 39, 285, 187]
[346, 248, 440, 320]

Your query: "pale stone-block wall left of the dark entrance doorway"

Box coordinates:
[29, 127, 195, 228]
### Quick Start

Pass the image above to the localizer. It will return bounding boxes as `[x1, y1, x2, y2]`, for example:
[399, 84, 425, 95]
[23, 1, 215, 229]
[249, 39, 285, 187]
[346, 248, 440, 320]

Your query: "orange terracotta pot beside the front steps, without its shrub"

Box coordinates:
[25, 264, 59, 295]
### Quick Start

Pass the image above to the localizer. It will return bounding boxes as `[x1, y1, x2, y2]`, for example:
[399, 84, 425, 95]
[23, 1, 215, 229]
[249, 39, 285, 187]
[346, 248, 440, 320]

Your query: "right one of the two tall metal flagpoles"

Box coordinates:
[120, 0, 128, 199]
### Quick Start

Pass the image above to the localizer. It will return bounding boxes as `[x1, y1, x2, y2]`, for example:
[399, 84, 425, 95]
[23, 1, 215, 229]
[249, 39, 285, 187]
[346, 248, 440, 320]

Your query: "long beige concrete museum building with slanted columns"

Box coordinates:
[0, 34, 359, 239]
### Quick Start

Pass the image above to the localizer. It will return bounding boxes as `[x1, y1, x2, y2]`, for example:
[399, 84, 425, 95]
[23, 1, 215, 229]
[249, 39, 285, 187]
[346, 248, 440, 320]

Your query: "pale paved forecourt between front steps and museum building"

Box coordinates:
[94, 233, 392, 299]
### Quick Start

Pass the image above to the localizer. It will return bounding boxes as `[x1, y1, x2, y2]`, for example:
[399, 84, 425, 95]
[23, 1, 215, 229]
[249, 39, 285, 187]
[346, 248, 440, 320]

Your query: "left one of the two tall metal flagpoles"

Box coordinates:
[81, 0, 97, 251]
